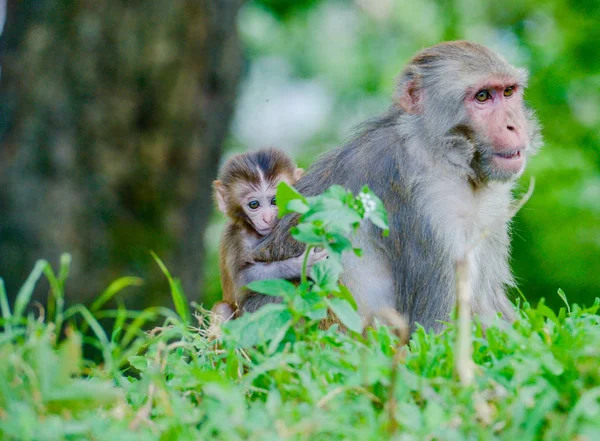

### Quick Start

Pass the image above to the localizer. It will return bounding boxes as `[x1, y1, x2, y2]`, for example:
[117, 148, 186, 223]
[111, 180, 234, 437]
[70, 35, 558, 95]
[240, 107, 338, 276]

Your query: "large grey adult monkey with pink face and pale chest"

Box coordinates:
[240, 41, 542, 330]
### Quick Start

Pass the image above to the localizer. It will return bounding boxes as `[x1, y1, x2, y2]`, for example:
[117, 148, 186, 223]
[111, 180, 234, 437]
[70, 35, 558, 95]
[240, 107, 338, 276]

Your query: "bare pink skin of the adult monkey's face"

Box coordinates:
[465, 81, 529, 174]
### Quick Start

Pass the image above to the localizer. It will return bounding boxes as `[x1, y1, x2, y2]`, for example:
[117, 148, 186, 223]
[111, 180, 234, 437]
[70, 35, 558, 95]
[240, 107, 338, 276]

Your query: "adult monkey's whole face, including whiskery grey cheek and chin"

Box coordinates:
[465, 80, 535, 181]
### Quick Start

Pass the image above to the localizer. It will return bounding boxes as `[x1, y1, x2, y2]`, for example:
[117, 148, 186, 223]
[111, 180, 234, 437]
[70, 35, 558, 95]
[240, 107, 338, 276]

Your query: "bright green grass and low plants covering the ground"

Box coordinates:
[0, 254, 600, 441]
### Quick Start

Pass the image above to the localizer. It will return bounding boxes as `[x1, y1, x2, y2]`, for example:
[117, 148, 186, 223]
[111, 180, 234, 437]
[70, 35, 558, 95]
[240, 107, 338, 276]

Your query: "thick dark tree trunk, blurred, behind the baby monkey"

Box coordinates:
[0, 0, 242, 307]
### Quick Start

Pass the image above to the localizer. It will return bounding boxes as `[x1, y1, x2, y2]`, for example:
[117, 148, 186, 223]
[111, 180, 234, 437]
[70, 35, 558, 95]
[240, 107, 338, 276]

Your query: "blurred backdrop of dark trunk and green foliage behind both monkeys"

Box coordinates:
[0, 0, 600, 307]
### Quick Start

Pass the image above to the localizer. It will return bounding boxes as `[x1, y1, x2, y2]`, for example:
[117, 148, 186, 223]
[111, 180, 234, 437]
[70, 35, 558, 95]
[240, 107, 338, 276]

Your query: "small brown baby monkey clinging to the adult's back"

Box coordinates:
[213, 149, 327, 320]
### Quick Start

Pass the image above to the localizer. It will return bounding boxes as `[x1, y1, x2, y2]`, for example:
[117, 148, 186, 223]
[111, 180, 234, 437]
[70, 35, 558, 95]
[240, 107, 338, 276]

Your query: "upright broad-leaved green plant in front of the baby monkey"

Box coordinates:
[226, 182, 388, 340]
